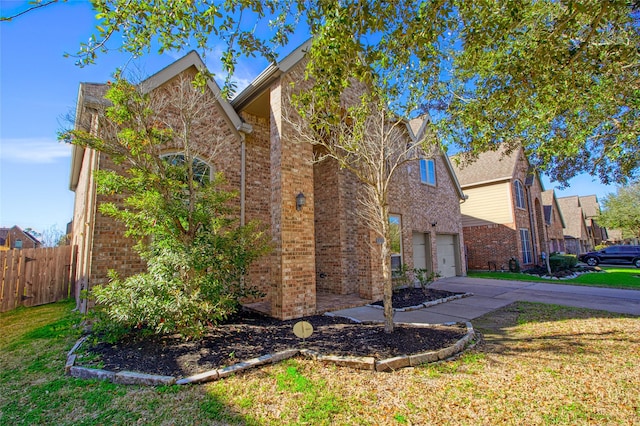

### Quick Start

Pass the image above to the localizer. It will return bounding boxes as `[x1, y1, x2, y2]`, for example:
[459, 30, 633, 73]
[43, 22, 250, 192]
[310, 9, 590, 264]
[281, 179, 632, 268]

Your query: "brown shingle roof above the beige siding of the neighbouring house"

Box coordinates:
[451, 146, 520, 188]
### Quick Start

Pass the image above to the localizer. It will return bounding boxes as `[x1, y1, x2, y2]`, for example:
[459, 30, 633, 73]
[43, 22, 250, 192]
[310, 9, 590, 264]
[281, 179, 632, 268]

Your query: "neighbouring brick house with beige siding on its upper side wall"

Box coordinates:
[454, 149, 548, 270]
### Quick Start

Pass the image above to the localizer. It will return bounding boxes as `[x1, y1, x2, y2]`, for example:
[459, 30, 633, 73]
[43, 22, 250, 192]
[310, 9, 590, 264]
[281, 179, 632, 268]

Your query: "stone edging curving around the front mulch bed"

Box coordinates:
[64, 322, 476, 386]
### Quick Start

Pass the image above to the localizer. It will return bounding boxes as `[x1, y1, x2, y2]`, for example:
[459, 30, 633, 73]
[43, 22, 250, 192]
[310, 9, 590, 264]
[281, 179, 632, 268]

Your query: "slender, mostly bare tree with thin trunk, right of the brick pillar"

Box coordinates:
[285, 82, 440, 333]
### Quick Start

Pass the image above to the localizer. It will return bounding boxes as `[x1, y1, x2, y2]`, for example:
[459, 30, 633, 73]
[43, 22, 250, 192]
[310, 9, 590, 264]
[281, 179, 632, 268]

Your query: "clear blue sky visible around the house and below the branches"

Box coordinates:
[0, 0, 615, 232]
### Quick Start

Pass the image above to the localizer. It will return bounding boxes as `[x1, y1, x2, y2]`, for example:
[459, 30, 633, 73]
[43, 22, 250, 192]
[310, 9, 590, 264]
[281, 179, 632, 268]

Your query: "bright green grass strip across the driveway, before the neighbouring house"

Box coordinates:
[468, 266, 640, 290]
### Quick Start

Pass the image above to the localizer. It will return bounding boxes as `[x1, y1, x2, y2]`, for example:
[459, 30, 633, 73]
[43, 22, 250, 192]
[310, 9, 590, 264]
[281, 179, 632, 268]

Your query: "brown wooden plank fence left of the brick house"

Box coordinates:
[0, 246, 77, 312]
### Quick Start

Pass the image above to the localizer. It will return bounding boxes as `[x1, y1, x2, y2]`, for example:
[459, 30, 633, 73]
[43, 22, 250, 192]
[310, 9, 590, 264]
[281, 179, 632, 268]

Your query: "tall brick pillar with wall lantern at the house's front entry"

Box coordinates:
[270, 68, 316, 319]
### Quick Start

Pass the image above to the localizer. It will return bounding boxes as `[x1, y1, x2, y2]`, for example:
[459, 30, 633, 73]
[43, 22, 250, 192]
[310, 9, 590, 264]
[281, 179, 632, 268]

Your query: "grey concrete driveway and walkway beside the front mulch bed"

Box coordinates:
[333, 277, 640, 324]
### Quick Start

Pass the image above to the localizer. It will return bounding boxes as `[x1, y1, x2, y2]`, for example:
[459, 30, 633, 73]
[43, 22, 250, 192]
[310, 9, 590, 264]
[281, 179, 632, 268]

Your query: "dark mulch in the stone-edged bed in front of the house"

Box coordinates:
[79, 290, 466, 377]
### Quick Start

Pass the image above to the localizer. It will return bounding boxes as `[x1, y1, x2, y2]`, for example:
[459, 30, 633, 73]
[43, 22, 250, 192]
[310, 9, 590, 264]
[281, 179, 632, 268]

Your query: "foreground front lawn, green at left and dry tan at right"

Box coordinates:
[0, 302, 640, 425]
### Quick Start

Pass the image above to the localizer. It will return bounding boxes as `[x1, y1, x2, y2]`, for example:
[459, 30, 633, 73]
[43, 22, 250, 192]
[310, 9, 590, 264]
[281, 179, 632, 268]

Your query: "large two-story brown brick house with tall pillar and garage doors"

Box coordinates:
[70, 45, 466, 319]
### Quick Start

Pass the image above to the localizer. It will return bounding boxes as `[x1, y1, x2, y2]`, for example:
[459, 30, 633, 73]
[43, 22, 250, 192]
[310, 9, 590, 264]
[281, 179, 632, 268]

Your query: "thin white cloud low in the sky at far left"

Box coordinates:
[0, 138, 71, 164]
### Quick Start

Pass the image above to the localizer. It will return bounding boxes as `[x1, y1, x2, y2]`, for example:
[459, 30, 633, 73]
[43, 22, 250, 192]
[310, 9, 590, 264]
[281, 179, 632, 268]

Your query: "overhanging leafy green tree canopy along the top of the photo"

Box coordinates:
[5, 0, 640, 183]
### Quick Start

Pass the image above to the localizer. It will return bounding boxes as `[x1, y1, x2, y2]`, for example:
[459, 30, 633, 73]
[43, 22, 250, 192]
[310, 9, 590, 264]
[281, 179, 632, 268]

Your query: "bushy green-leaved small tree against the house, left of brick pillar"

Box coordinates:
[62, 78, 266, 335]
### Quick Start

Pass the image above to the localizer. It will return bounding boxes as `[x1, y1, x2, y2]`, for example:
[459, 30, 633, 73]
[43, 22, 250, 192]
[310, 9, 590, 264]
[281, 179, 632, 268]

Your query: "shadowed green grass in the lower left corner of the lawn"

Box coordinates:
[0, 302, 259, 425]
